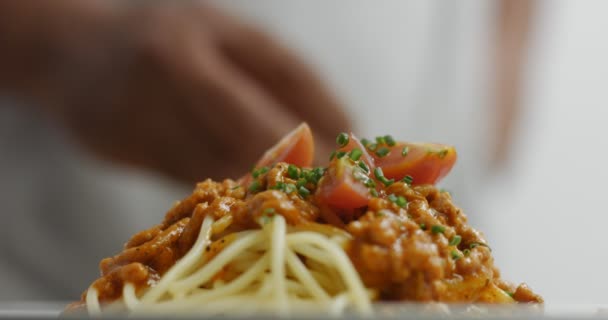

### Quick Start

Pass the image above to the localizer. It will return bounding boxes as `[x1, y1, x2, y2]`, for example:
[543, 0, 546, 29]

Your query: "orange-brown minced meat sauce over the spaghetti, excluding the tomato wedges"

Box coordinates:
[69, 163, 543, 309]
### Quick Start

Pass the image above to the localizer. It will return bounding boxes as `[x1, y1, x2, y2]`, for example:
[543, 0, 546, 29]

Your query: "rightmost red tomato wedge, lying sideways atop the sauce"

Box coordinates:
[374, 142, 457, 185]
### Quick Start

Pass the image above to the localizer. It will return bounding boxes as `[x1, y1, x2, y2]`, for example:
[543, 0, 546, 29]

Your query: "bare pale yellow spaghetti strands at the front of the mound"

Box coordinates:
[86, 215, 372, 316]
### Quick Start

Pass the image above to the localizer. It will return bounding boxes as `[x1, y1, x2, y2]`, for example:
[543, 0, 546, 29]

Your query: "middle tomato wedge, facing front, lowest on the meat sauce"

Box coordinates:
[317, 157, 371, 209]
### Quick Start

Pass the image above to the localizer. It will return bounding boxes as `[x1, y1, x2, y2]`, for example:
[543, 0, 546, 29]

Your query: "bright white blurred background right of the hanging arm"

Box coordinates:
[481, 1, 608, 304]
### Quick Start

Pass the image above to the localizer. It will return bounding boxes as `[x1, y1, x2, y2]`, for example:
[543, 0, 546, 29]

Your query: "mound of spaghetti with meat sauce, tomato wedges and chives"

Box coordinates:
[68, 124, 543, 315]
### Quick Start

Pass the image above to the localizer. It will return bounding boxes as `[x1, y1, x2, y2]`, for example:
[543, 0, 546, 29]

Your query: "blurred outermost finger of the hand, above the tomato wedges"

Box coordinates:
[200, 9, 350, 148]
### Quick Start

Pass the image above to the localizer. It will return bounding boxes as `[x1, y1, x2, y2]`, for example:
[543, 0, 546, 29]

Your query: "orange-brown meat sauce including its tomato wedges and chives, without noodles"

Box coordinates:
[70, 126, 543, 309]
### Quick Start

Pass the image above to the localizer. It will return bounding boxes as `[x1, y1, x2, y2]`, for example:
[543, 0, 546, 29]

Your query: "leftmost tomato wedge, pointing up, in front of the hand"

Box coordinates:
[240, 122, 315, 184]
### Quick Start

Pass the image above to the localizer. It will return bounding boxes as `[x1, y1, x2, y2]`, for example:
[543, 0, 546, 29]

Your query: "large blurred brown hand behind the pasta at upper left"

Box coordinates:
[28, 1, 349, 182]
